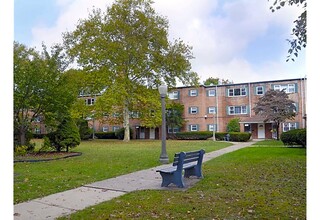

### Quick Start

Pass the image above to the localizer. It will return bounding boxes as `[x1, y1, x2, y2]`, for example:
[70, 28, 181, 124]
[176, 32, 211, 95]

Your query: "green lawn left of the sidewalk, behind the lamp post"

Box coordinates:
[14, 140, 230, 204]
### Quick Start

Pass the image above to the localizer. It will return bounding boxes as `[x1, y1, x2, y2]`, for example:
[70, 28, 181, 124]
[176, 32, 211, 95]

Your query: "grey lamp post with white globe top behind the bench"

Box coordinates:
[158, 85, 169, 164]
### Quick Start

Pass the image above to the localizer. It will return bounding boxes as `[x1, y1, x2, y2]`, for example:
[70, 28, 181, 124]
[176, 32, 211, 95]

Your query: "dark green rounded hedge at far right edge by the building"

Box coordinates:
[280, 129, 307, 147]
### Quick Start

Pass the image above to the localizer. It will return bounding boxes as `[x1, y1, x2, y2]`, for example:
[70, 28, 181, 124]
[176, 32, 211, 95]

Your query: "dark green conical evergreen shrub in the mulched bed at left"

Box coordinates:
[48, 117, 80, 152]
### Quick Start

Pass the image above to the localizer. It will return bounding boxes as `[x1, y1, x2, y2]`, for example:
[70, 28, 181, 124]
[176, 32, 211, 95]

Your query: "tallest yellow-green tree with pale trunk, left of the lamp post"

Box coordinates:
[64, 0, 199, 141]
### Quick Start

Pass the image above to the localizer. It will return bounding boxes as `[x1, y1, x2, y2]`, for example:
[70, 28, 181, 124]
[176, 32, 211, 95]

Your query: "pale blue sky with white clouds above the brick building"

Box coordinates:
[14, 0, 306, 83]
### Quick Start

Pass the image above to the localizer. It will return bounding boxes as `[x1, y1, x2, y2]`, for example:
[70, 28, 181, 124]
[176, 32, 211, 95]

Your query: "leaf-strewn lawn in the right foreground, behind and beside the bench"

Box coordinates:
[60, 142, 306, 219]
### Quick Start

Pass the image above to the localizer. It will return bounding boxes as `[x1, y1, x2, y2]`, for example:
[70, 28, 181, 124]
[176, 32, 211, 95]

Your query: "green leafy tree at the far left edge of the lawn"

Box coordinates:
[13, 42, 76, 145]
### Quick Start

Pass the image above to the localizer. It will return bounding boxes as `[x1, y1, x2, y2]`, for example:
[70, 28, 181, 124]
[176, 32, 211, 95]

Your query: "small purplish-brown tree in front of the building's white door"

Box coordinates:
[253, 90, 296, 140]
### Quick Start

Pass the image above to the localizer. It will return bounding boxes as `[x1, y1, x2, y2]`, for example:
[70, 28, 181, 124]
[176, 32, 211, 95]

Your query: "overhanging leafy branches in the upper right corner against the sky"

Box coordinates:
[269, 0, 307, 61]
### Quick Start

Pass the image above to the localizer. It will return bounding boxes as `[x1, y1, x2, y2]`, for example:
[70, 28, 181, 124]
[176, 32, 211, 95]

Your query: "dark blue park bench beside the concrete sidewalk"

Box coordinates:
[156, 150, 205, 188]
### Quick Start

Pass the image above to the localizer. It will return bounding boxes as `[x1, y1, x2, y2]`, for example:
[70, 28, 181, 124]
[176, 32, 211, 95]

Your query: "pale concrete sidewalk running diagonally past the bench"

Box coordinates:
[14, 141, 255, 220]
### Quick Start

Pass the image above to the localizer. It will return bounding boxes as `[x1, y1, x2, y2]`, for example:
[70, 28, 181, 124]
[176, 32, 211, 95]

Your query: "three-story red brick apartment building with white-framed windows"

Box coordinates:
[31, 78, 307, 139]
